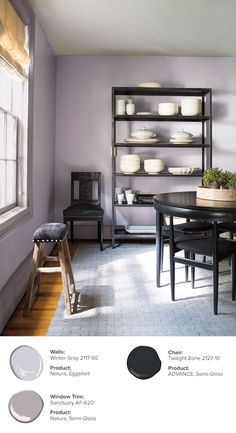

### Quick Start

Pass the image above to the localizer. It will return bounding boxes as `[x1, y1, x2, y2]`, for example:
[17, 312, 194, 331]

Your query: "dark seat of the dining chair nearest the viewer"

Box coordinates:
[175, 235, 236, 261]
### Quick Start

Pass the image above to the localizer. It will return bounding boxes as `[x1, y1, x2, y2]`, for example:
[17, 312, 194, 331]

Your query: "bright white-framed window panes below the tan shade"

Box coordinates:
[0, 57, 28, 224]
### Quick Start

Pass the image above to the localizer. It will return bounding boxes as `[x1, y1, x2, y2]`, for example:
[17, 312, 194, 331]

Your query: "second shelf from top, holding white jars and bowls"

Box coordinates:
[114, 114, 210, 122]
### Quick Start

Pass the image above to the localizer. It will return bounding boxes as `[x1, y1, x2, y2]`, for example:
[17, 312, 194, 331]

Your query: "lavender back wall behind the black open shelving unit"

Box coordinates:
[55, 56, 236, 237]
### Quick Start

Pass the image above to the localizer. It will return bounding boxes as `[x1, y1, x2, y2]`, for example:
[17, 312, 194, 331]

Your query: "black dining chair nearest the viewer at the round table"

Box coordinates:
[170, 217, 236, 315]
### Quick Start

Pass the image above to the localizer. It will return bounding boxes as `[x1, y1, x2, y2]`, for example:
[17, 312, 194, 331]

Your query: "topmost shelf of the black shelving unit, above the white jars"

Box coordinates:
[112, 86, 211, 96]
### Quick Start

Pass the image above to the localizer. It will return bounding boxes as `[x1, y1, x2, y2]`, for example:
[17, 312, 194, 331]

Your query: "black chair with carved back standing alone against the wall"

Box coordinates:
[63, 172, 104, 251]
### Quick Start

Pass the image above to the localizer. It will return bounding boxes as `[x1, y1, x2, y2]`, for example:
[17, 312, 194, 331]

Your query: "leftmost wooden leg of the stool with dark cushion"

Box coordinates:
[23, 244, 42, 317]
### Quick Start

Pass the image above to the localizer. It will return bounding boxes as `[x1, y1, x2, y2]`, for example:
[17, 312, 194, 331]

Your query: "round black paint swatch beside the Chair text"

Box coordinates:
[127, 346, 161, 379]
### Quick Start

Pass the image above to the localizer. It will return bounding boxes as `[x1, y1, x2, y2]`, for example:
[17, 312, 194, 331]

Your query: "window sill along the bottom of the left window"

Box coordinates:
[0, 206, 32, 237]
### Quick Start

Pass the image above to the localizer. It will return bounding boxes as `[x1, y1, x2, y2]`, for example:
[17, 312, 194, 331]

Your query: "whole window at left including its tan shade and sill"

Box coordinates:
[0, 0, 30, 234]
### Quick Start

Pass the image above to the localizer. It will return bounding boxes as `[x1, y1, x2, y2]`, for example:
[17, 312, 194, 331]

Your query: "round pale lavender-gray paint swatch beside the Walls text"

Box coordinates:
[10, 346, 43, 380]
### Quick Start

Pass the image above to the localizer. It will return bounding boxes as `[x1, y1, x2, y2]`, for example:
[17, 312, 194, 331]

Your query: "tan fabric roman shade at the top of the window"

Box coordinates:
[0, 0, 30, 79]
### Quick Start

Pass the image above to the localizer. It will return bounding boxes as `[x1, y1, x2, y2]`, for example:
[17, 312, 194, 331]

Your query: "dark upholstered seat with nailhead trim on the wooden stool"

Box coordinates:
[32, 223, 68, 242]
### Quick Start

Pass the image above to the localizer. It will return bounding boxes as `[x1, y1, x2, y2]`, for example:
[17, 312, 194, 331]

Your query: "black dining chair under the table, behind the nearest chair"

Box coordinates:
[159, 215, 212, 281]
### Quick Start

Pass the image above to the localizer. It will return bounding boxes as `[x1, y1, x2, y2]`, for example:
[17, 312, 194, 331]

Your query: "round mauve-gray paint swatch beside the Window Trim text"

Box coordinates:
[9, 391, 43, 423]
